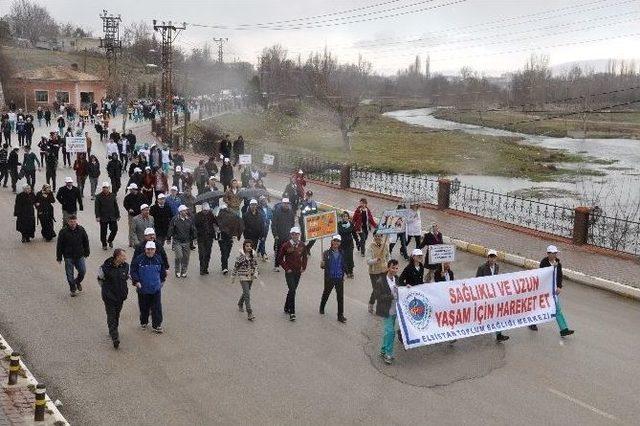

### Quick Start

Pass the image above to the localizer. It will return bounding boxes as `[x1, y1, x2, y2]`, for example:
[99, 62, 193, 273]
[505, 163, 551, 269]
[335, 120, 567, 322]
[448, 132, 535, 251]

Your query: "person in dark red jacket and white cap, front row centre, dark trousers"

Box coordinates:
[276, 226, 307, 321]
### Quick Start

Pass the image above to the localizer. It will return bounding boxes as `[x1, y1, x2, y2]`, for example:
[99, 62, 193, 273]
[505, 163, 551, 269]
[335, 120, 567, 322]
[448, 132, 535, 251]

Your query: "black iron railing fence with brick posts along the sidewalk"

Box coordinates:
[245, 147, 640, 255]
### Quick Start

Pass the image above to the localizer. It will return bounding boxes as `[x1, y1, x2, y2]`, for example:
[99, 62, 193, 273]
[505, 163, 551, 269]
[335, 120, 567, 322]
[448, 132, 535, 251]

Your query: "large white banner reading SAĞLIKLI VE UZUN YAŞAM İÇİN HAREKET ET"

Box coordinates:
[396, 266, 556, 349]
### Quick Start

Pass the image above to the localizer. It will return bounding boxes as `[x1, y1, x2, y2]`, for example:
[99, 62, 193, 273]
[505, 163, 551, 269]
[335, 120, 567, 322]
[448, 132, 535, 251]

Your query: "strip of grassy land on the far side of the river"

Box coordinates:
[434, 109, 640, 139]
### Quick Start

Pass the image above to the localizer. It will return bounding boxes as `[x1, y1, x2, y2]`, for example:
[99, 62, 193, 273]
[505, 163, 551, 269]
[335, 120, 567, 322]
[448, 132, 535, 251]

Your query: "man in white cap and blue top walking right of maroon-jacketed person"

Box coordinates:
[320, 235, 347, 324]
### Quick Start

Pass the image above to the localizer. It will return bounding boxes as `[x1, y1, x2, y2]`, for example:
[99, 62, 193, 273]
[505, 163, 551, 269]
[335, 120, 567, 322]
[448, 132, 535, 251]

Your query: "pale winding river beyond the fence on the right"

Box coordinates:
[385, 108, 640, 218]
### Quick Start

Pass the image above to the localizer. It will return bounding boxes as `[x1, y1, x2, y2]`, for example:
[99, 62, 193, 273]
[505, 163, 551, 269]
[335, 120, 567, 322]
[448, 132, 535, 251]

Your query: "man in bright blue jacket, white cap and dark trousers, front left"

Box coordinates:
[130, 241, 167, 333]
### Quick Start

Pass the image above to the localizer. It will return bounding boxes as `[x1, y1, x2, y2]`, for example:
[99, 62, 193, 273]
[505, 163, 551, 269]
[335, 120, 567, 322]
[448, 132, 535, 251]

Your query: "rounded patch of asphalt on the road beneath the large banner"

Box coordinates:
[362, 321, 505, 388]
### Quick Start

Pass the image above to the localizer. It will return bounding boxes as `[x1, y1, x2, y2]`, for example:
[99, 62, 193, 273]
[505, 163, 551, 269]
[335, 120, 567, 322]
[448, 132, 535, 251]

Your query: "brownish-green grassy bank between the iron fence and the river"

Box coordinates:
[200, 108, 596, 180]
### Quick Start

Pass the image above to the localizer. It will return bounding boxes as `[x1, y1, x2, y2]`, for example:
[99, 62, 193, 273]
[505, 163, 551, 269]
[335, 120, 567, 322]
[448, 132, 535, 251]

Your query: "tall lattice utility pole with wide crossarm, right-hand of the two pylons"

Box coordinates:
[153, 19, 186, 149]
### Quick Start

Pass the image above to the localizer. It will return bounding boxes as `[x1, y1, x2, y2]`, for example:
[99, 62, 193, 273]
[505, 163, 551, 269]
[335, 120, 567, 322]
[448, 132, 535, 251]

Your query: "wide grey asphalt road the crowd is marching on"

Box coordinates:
[0, 117, 640, 425]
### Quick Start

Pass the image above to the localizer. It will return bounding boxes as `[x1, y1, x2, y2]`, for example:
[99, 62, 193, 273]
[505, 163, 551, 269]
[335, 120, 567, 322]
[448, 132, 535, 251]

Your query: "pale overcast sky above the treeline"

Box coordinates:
[5, 0, 640, 75]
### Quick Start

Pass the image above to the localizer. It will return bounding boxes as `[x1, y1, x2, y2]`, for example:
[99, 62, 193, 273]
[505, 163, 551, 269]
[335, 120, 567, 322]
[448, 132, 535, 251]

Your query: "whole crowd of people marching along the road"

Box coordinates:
[0, 105, 573, 364]
